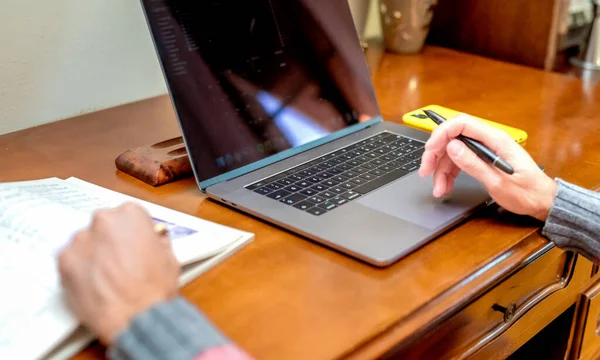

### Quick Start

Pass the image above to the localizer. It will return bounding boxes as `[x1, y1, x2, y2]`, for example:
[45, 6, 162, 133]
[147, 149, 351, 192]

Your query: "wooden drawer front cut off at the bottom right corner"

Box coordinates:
[571, 279, 600, 359]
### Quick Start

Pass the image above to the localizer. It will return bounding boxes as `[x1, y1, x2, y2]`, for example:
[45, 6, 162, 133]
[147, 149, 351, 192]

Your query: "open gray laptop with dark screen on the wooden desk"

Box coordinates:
[142, 0, 490, 267]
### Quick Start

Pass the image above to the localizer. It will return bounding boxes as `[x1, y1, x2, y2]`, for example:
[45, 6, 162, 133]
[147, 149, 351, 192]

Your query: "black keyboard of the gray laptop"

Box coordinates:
[246, 131, 425, 216]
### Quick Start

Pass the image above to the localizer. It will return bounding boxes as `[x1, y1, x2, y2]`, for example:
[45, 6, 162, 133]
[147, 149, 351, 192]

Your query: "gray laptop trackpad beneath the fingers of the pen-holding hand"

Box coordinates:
[358, 174, 489, 229]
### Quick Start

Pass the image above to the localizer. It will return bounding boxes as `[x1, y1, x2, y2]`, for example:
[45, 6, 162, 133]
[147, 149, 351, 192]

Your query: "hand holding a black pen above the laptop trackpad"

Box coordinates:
[419, 114, 557, 221]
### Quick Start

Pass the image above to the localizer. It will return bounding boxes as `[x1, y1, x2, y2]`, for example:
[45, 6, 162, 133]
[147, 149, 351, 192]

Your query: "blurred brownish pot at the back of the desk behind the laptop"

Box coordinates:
[379, 0, 437, 54]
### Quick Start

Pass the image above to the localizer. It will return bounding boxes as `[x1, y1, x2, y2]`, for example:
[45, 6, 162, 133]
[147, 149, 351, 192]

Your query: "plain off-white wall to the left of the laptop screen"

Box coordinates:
[0, 0, 166, 134]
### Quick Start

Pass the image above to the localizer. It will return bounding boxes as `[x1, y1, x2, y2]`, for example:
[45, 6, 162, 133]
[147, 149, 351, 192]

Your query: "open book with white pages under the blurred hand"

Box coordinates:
[0, 178, 254, 359]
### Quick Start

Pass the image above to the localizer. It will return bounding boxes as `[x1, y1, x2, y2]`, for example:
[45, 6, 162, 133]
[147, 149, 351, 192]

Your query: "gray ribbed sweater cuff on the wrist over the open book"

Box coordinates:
[107, 297, 229, 360]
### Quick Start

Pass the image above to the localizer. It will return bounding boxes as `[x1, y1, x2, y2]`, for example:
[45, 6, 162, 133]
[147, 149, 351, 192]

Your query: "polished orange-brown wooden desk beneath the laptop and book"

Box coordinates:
[0, 47, 600, 360]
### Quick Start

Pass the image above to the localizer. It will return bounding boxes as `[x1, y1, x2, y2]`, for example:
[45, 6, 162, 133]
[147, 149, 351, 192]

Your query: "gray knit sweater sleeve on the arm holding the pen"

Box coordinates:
[542, 179, 600, 263]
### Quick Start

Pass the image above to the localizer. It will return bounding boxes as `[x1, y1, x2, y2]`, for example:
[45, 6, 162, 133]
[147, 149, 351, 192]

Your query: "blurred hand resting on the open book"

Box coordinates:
[58, 204, 180, 345]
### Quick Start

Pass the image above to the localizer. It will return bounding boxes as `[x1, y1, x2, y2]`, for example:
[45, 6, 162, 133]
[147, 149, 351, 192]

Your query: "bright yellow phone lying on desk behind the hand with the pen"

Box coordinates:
[402, 105, 527, 144]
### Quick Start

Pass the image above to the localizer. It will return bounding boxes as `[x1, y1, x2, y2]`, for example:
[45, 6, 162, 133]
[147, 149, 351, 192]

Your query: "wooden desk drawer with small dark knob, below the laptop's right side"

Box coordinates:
[392, 248, 592, 359]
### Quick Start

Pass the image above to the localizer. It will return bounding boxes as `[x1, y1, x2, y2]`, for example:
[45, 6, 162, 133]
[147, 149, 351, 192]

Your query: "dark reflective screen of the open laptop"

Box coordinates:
[142, 0, 380, 181]
